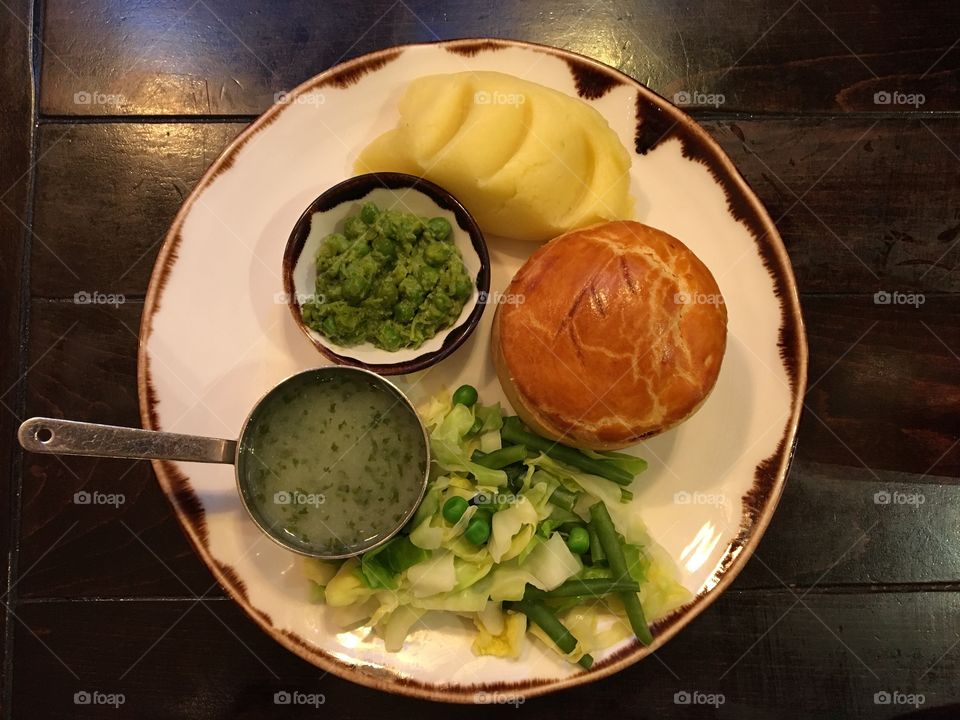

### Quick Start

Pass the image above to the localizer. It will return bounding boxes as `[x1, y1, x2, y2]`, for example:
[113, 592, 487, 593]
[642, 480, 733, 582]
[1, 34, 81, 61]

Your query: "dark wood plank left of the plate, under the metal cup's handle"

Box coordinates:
[18, 301, 222, 598]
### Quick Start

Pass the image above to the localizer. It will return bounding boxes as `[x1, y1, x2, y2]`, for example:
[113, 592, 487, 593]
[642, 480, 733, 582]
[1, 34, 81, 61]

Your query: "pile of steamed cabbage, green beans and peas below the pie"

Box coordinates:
[304, 388, 688, 667]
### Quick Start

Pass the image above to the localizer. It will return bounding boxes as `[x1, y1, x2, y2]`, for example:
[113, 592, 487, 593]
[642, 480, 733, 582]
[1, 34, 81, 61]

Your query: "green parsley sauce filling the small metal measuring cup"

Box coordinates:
[238, 373, 427, 555]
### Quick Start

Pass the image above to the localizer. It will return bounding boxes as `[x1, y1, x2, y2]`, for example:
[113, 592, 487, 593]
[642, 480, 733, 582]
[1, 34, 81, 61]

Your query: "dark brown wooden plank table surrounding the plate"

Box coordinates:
[0, 0, 960, 720]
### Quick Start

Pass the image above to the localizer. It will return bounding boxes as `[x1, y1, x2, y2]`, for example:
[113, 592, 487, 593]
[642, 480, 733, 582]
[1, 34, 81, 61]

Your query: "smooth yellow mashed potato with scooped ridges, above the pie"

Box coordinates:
[355, 72, 633, 241]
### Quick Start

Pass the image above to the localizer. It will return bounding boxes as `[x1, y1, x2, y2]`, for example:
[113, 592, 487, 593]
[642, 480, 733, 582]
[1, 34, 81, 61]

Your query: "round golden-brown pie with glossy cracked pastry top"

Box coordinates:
[493, 221, 727, 448]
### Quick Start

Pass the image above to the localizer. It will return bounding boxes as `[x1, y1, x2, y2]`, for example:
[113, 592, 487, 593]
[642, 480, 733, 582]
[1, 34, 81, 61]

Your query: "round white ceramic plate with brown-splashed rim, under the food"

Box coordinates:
[139, 40, 807, 702]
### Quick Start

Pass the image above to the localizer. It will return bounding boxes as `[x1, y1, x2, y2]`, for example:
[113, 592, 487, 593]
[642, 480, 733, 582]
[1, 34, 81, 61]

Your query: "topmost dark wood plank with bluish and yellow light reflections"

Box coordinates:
[41, 0, 960, 115]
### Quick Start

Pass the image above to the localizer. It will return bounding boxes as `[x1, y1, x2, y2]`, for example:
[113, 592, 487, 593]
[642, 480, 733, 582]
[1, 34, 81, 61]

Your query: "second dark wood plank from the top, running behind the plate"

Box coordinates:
[33, 118, 960, 297]
